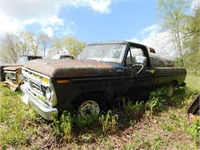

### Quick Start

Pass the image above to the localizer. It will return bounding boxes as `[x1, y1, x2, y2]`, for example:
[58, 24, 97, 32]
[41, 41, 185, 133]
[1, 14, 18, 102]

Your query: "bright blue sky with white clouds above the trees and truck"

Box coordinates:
[0, 0, 200, 58]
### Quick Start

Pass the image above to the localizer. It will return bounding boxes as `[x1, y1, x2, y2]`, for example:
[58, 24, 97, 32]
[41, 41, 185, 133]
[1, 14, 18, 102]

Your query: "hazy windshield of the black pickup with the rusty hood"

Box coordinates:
[78, 43, 126, 63]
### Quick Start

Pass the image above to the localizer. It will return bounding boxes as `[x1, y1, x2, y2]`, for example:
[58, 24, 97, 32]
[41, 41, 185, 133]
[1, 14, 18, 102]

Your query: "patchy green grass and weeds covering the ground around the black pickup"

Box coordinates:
[0, 73, 200, 150]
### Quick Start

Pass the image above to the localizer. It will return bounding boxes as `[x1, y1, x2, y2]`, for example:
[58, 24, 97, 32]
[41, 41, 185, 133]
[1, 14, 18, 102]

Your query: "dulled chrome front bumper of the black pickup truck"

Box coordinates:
[20, 84, 58, 120]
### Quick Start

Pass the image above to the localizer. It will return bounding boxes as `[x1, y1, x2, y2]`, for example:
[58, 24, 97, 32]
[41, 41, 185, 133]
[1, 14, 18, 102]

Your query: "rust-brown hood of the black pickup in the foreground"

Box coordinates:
[24, 59, 122, 78]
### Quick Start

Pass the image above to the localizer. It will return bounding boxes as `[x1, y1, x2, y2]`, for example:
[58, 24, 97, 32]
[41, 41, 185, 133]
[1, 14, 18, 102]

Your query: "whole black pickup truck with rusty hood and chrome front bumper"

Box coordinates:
[21, 41, 186, 120]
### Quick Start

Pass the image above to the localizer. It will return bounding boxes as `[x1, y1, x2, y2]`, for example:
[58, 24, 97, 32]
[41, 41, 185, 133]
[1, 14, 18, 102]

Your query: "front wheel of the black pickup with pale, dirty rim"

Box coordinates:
[76, 94, 106, 118]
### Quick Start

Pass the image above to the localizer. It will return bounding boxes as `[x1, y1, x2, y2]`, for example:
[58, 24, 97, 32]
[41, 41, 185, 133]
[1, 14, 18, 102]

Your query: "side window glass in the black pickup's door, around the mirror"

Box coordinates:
[126, 47, 146, 66]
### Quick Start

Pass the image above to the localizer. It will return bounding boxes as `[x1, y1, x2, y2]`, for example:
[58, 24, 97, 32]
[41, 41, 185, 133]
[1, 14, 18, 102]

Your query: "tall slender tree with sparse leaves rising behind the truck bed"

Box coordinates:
[158, 0, 188, 66]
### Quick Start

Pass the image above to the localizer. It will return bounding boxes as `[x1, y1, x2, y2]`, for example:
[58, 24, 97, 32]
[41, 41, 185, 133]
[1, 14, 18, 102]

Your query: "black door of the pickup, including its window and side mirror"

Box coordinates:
[125, 45, 154, 100]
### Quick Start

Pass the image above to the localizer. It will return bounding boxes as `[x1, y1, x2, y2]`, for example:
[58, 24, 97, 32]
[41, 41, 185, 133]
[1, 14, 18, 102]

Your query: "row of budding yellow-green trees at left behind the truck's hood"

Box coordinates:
[0, 31, 86, 63]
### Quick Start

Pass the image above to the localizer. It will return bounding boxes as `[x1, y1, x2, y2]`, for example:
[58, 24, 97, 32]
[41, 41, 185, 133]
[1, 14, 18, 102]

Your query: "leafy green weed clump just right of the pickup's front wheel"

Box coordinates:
[99, 110, 118, 134]
